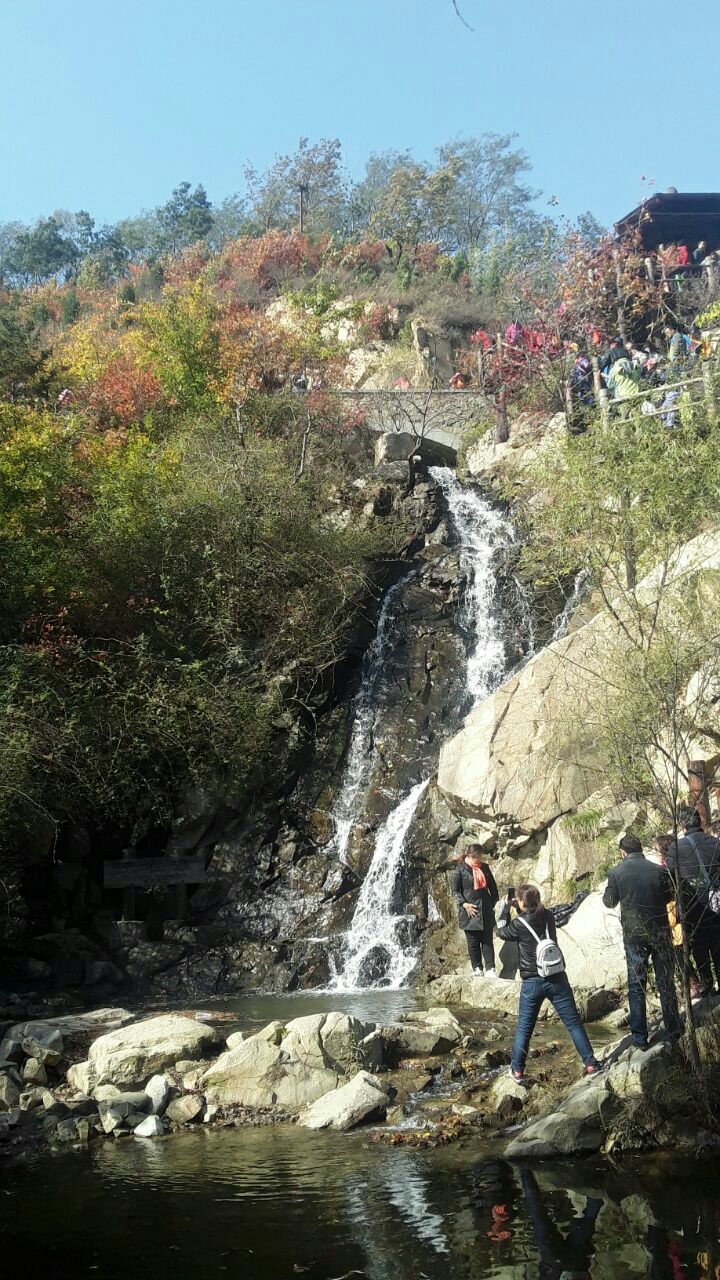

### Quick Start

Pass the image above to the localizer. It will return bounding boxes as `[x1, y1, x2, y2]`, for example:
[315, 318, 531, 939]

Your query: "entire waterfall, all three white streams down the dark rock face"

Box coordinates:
[333, 467, 523, 991]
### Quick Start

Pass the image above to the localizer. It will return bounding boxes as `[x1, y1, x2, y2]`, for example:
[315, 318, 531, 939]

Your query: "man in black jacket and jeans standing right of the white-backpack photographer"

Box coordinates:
[602, 835, 680, 1048]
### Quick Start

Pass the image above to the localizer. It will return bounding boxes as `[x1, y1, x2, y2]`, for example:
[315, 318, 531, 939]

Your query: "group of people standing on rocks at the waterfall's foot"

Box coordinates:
[451, 808, 720, 1083]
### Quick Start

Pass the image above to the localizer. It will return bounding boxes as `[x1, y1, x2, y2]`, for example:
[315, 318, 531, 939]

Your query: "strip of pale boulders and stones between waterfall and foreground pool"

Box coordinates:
[0, 982, 717, 1160]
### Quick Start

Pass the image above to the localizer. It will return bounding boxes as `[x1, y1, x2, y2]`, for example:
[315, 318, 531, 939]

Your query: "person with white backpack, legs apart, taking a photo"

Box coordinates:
[497, 884, 601, 1083]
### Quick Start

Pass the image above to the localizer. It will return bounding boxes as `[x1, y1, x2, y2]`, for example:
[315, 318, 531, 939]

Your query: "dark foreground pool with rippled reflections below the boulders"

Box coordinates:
[0, 1126, 720, 1280]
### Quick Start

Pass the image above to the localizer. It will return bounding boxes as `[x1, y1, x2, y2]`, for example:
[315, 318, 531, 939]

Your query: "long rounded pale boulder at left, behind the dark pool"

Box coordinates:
[68, 1014, 223, 1093]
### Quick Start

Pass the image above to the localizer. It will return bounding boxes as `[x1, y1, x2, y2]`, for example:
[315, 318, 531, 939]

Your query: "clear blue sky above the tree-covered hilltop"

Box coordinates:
[0, 0, 720, 223]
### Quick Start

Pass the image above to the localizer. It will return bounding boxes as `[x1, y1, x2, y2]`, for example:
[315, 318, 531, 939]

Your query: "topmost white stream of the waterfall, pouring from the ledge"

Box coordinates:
[430, 467, 515, 703]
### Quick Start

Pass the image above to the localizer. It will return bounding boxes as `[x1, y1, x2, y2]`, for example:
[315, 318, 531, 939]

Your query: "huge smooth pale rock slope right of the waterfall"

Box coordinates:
[438, 530, 720, 837]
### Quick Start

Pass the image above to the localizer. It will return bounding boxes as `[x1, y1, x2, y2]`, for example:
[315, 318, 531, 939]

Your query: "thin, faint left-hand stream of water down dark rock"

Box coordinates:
[332, 572, 414, 863]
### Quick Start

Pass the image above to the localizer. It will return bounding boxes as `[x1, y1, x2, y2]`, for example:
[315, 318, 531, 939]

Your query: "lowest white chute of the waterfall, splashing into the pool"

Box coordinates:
[333, 778, 430, 991]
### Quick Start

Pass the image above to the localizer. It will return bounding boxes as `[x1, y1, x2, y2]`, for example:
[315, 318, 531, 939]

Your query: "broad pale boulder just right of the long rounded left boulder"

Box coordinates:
[200, 1036, 338, 1111]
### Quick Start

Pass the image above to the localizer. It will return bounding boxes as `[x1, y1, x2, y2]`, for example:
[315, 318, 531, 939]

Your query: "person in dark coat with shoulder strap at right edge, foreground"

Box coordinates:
[665, 808, 720, 997]
